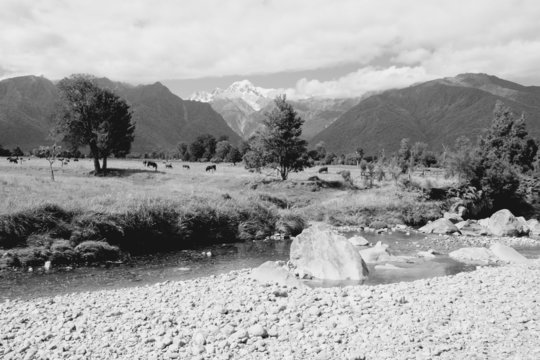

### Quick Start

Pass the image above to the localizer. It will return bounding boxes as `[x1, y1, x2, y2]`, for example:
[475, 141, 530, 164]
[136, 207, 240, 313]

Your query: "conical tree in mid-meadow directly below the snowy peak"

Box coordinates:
[252, 95, 307, 180]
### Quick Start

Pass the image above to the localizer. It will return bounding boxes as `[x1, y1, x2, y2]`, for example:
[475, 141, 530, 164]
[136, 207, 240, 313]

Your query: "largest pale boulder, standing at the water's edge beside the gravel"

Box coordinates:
[290, 223, 368, 280]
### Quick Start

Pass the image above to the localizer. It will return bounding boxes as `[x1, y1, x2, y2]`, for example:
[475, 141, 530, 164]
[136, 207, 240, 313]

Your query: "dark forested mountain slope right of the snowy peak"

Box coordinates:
[311, 74, 540, 154]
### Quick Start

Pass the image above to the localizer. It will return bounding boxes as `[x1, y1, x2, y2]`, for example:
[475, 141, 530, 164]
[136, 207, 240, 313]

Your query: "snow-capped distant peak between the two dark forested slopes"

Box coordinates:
[190, 80, 360, 139]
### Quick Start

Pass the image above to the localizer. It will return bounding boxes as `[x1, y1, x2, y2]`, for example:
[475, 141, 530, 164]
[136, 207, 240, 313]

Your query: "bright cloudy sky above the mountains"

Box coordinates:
[0, 0, 540, 98]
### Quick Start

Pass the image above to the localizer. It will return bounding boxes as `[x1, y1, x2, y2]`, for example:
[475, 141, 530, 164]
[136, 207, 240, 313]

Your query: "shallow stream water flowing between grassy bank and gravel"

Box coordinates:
[0, 232, 540, 301]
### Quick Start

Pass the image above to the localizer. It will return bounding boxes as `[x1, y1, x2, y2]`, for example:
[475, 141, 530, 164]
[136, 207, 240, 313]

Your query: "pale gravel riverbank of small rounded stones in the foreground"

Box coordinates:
[0, 260, 540, 360]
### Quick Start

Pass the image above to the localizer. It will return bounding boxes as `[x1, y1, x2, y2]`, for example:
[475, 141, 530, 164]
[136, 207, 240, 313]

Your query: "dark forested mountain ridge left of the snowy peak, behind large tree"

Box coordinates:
[0, 76, 240, 153]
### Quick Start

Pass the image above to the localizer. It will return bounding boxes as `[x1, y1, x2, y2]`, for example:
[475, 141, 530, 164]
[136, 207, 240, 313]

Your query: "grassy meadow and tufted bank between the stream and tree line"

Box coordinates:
[0, 159, 452, 267]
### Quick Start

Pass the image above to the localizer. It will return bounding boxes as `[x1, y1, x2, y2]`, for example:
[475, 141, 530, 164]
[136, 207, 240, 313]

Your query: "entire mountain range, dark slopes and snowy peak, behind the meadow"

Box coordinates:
[0, 74, 540, 154]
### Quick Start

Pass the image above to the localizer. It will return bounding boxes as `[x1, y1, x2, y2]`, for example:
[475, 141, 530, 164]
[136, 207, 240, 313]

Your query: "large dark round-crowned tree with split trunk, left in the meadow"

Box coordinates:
[55, 75, 135, 174]
